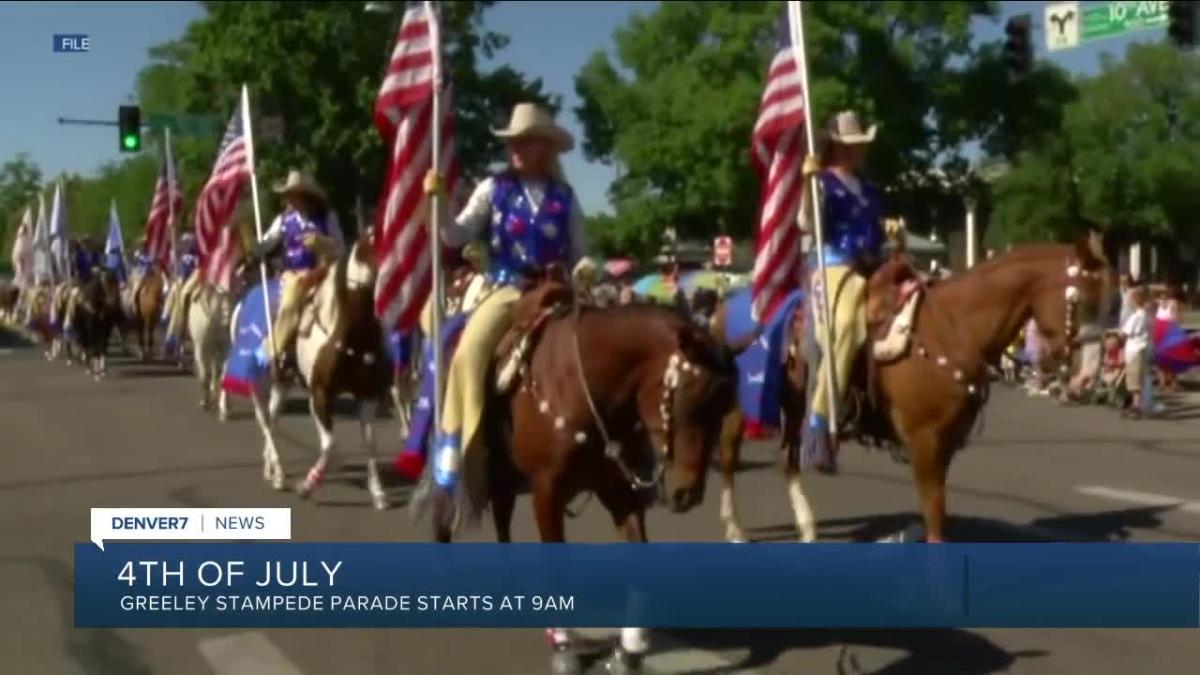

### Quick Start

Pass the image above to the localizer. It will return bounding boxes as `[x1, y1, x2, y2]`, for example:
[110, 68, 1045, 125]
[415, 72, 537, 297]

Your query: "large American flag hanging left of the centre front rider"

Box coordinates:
[374, 2, 458, 330]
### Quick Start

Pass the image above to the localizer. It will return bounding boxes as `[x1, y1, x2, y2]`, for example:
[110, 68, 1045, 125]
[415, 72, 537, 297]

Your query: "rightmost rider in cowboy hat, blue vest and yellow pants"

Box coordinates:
[800, 110, 884, 472]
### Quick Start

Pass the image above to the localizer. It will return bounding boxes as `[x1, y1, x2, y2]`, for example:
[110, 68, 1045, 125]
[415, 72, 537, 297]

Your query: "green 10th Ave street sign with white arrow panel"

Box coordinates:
[1045, 2, 1170, 52]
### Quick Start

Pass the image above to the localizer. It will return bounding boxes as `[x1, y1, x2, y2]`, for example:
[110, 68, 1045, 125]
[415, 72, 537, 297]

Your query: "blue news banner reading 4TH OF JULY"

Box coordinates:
[74, 543, 1200, 628]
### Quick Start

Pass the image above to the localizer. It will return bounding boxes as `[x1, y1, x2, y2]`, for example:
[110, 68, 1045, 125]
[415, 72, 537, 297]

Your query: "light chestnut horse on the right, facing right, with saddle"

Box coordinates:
[705, 238, 1111, 542]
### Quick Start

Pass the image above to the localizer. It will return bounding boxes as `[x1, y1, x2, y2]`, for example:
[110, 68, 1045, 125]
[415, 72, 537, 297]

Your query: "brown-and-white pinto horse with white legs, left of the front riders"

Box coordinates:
[253, 234, 391, 510]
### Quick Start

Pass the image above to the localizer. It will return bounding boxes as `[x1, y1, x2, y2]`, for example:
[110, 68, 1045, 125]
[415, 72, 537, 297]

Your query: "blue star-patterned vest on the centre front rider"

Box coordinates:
[490, 173, 572, 283]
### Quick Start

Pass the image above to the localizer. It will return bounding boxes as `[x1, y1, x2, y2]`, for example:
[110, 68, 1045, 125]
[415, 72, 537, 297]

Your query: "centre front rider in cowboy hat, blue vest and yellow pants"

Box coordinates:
[425, 103, 587, 489]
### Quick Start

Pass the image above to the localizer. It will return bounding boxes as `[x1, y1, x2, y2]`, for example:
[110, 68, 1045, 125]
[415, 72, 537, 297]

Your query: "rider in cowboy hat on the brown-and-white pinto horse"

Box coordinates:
[247, 171, 346, 363]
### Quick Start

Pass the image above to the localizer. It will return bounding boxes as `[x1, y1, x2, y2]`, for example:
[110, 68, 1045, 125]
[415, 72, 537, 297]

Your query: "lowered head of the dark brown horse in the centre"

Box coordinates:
[662, 323, 737, 512]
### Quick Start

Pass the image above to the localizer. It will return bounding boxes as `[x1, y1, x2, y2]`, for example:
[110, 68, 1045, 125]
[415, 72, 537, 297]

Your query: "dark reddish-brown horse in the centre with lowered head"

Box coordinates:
[426, 271, 733, 671]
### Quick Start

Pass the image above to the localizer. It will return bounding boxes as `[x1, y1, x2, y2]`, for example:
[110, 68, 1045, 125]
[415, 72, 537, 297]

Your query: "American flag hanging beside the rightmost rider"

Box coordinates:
[750, 11, 808, 321]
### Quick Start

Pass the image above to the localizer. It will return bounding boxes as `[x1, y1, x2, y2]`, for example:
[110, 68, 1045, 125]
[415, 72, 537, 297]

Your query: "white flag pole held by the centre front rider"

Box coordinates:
[432, 0, 445, 425]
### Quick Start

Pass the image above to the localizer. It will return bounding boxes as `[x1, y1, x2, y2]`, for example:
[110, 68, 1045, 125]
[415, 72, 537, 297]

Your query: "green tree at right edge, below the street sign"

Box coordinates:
[995, 44, 1200, 249]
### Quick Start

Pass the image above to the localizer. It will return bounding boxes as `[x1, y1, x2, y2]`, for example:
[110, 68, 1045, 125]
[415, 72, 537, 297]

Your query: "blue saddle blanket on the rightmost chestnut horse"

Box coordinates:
[725, 283, 804, 428]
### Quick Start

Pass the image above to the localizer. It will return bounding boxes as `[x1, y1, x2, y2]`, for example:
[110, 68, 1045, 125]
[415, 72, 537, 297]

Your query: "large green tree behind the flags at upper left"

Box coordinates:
[138, 1, 558, 229]
